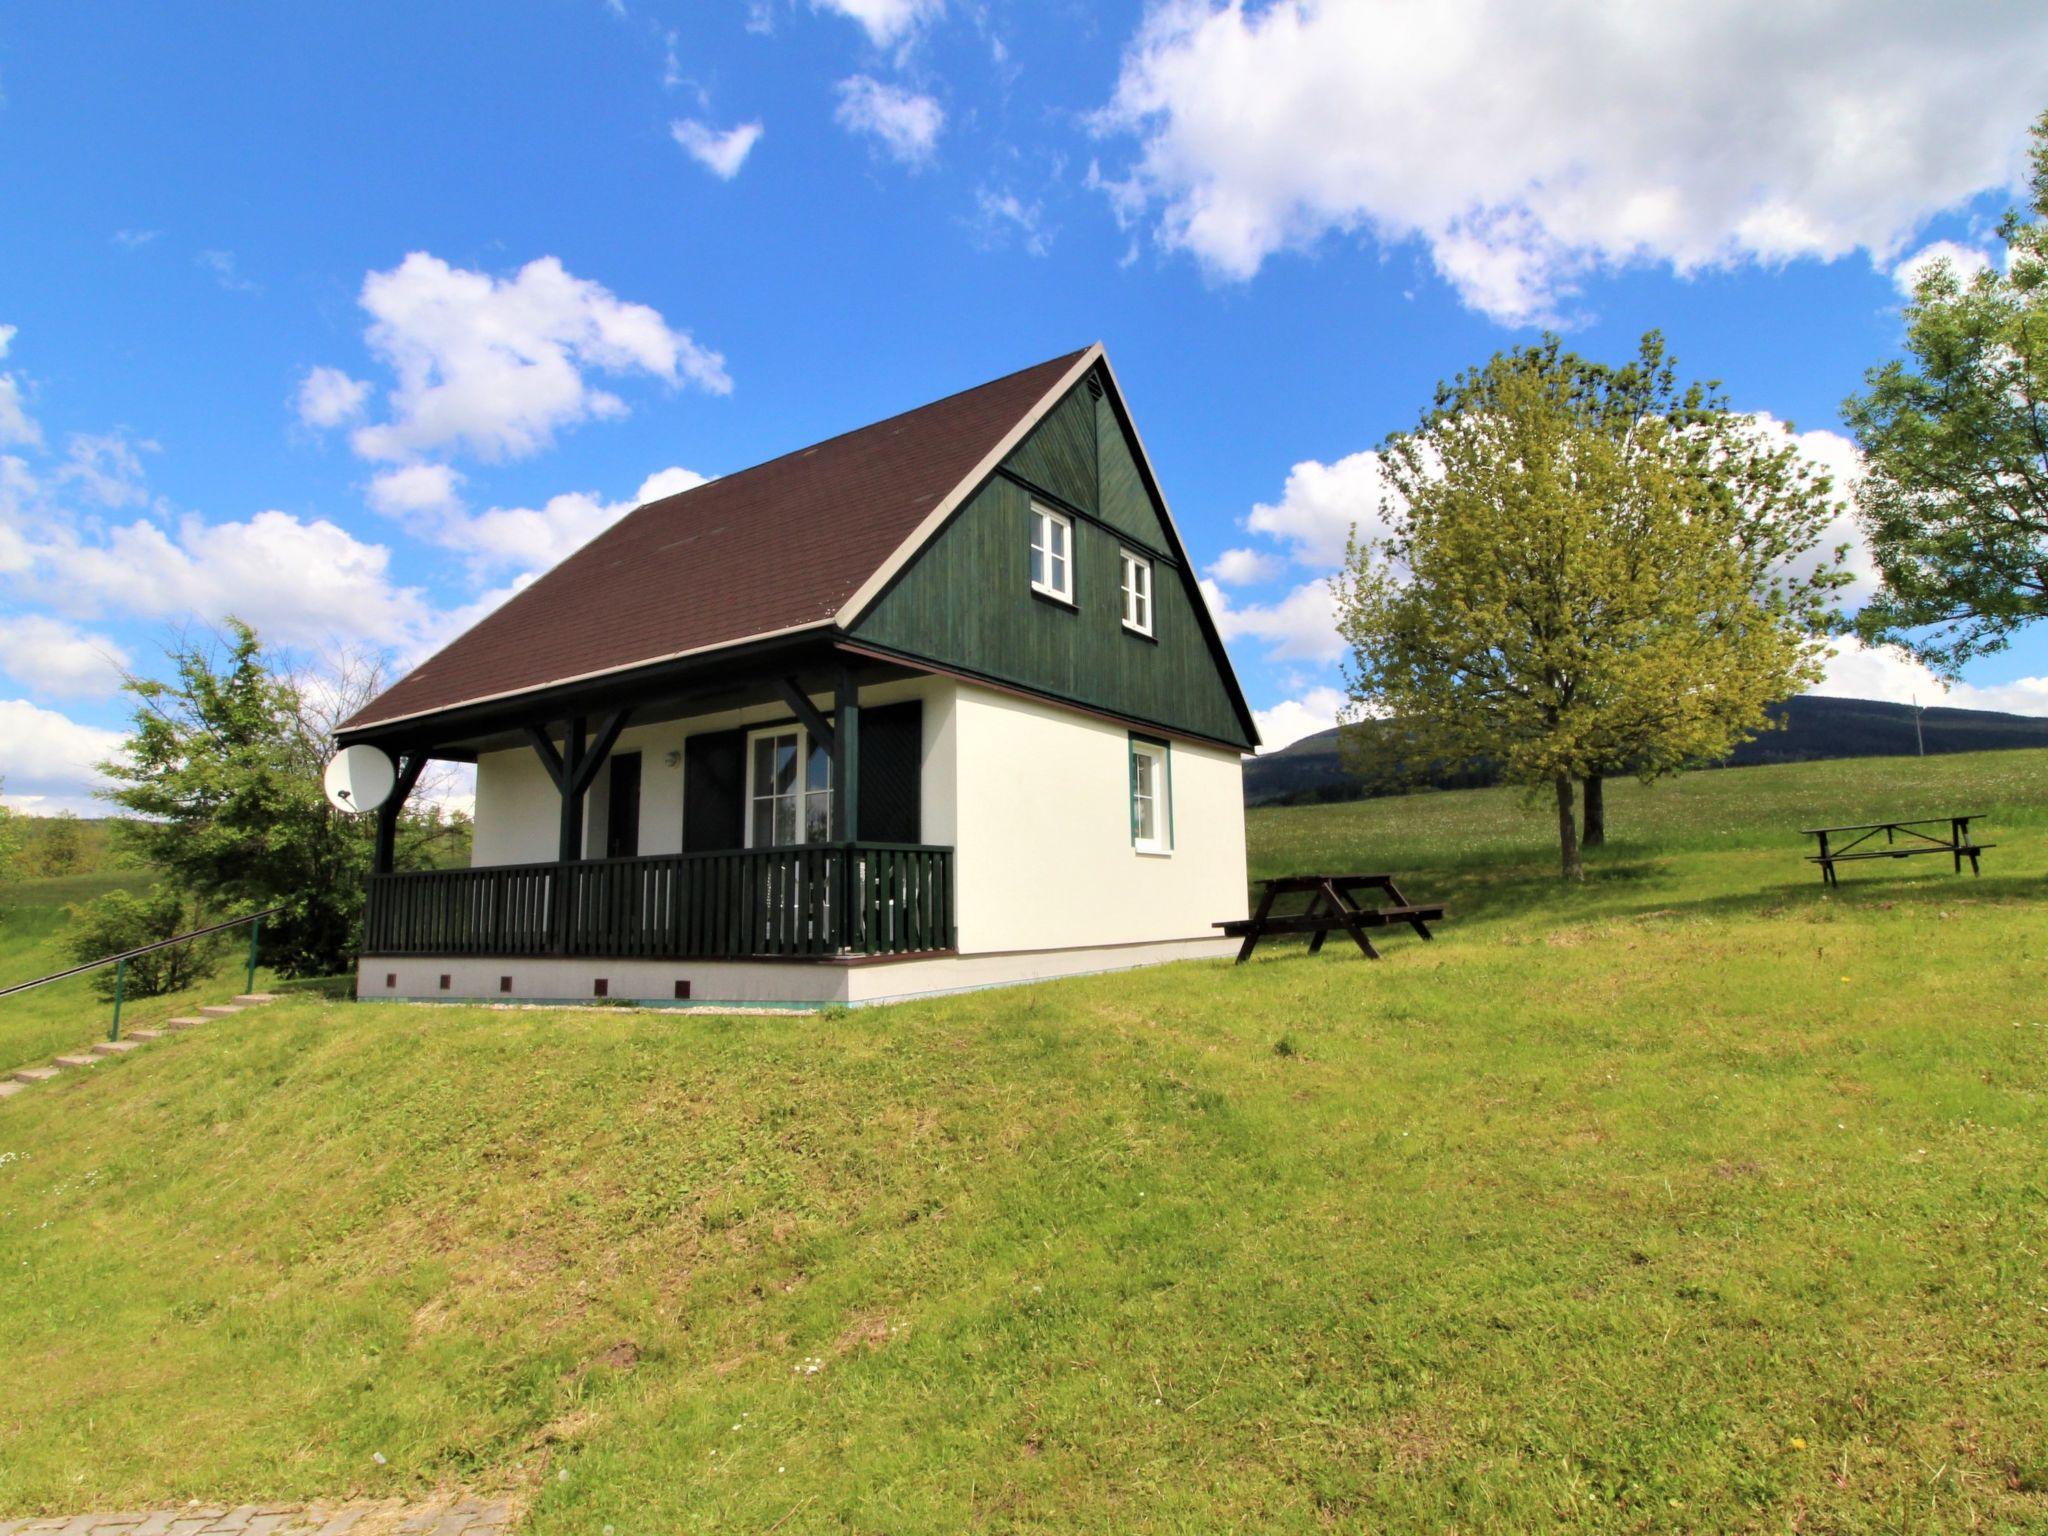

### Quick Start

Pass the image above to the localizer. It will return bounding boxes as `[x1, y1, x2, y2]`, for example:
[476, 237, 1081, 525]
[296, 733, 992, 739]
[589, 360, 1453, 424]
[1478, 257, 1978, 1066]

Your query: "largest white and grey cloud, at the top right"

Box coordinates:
[1098, 0, 2048, 324]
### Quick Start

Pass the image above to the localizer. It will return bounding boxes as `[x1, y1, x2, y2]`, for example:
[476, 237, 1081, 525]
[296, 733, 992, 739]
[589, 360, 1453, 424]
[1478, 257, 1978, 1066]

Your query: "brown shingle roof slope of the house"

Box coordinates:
[344, 348, 1087, 729]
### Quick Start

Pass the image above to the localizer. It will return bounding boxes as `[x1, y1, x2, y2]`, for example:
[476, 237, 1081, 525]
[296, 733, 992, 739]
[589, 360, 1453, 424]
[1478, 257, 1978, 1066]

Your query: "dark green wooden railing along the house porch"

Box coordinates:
[362, 842, 954, 961]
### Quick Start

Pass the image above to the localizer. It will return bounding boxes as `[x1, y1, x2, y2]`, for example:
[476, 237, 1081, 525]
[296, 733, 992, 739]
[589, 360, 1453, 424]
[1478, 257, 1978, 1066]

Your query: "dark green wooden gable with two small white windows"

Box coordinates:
[850, 371, 1251, 750]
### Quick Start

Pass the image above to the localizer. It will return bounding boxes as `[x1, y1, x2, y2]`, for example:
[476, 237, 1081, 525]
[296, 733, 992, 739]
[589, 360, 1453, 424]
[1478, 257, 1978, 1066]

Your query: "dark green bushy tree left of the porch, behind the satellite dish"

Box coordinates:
[100, 618, 464, 975]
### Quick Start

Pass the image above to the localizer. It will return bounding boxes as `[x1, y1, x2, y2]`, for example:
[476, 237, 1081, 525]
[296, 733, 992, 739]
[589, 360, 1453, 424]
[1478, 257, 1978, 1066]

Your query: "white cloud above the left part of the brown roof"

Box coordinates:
[350, 252, 733, 463]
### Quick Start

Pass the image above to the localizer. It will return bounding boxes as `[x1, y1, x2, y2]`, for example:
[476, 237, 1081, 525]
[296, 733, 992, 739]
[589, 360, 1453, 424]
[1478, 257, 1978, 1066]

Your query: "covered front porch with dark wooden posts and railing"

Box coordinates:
[342, 641, 956, 965]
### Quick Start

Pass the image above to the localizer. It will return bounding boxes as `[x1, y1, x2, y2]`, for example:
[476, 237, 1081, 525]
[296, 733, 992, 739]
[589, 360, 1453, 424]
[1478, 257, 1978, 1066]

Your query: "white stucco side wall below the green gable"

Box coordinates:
[952, 686, 1245, 954]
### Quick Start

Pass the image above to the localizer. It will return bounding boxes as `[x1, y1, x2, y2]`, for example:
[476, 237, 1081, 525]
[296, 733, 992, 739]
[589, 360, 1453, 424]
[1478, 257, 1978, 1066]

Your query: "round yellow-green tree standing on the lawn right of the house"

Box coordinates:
[1337, 342, 1847, 879]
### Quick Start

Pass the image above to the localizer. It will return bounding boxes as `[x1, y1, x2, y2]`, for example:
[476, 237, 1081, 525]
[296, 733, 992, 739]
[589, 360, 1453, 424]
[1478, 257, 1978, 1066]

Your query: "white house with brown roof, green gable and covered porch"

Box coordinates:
[338, 346, 1257, 1006]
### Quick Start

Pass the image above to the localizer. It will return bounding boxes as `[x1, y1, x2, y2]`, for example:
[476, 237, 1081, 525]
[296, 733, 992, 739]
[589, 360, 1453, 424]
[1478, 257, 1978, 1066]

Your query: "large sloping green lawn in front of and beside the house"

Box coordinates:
[0, 752, 2048, 1536]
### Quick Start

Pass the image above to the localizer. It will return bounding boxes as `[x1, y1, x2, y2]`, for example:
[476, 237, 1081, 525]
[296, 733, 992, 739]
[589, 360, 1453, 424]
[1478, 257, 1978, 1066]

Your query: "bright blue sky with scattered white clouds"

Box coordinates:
[0, 0, 2048, 809]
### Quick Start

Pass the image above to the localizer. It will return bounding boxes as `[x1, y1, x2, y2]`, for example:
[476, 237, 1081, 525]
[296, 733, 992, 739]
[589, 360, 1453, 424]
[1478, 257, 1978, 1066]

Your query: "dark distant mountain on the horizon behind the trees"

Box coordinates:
[1245, 694, 2048, 805]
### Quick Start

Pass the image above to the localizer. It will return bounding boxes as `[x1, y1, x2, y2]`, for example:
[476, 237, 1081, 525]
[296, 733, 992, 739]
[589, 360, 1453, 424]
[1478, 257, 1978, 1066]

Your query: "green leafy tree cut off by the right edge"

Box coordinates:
[1843, 113, 2048, 674]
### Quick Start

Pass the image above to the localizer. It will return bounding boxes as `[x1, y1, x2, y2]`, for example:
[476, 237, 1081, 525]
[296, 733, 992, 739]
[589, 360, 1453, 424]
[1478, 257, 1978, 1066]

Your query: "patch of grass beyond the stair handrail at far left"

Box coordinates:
[0, 870, 268, 1081]
